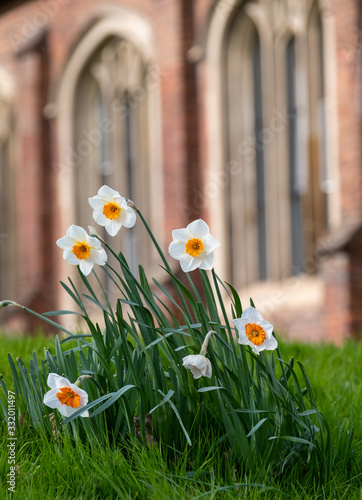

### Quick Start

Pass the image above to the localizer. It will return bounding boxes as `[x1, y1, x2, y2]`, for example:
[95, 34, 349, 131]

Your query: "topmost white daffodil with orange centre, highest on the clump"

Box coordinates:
[88, 186, 136, 236]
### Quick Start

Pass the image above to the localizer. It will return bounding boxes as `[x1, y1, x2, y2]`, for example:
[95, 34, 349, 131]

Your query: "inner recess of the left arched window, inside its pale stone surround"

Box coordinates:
[74, 37, 150, 272]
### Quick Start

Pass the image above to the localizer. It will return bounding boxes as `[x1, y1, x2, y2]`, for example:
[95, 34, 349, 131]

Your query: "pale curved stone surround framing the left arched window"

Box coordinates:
[54, 8, 163, 310]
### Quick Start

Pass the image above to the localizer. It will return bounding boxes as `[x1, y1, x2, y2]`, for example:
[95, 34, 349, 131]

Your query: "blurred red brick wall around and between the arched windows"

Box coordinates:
[0, 0, 362, 342]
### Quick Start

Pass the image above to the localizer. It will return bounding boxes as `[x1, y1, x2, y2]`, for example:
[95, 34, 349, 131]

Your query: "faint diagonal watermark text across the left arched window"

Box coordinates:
[52, 66, 163, 175]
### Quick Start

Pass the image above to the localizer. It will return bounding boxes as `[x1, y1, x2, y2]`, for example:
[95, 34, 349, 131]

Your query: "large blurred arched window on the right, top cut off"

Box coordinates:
[205, 0, 340, 288]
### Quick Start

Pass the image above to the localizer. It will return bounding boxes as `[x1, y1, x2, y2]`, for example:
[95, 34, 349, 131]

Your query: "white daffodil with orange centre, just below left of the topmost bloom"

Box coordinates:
[57, 224, 107, 276]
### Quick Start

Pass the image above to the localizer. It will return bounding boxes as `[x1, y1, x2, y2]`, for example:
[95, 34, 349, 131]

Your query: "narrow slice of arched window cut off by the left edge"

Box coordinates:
[0, 71, 16, 299]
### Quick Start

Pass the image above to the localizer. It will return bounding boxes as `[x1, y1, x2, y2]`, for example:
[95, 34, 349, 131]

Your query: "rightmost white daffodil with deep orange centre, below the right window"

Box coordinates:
[232, 307, 278, 354]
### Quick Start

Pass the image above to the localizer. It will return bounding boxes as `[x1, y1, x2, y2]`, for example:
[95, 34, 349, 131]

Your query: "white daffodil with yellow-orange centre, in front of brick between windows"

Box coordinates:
[169, 219, 220, 273]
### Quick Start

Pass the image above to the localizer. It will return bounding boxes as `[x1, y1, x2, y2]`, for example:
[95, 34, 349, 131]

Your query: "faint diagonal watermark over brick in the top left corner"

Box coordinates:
[6, 0, 70, 52]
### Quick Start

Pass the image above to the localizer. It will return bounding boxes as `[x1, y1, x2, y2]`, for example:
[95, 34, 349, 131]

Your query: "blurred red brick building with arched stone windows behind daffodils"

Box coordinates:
[0, 0, 362, 342]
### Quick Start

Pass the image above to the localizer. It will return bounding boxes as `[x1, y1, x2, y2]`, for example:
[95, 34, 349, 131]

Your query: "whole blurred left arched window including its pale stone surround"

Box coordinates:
[54, 12, 164, 309]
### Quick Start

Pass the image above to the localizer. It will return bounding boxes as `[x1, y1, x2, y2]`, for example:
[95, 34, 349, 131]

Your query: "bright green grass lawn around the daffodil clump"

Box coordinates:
[0, 335, 362, 500]
